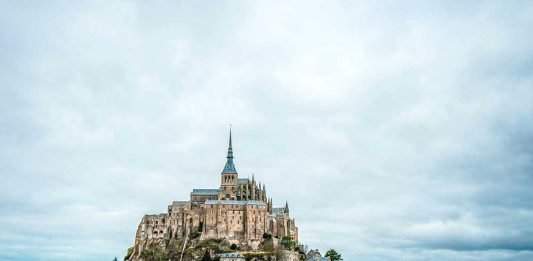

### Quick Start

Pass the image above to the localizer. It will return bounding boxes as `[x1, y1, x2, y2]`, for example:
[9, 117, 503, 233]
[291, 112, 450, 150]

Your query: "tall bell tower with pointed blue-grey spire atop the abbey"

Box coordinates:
[218, 127, 238, 200]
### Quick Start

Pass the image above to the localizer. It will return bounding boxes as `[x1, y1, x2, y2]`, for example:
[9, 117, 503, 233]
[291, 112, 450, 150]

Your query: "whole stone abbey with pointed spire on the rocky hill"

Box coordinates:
[130, 130, 298, 260]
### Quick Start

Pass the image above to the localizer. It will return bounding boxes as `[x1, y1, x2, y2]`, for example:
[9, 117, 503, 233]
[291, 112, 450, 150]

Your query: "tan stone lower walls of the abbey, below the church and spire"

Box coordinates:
[127, 200, 298, 260]
